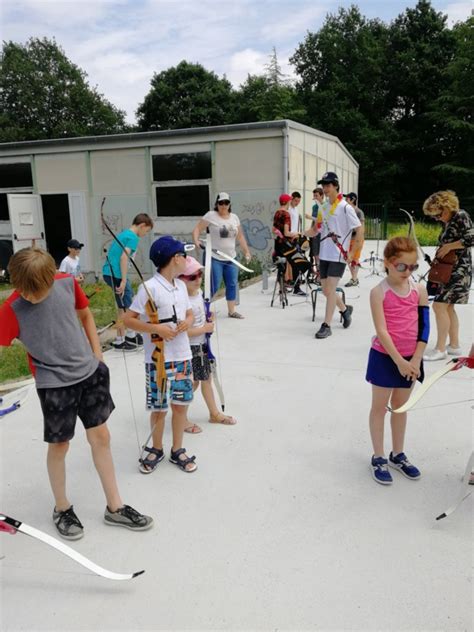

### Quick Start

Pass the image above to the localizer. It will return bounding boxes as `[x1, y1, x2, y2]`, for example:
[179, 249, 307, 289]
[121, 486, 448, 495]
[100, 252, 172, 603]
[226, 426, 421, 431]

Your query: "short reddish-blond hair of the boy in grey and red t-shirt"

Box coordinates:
[8, 248, 56, 295]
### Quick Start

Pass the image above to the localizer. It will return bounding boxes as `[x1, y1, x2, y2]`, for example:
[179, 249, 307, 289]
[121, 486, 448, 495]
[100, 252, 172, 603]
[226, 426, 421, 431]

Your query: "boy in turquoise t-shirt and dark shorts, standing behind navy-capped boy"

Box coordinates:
[102, 213, 153, 351]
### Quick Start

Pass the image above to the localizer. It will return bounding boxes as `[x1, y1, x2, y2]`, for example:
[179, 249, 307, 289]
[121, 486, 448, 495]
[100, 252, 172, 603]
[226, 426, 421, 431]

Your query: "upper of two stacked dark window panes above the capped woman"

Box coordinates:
[153, 151, 212, 182]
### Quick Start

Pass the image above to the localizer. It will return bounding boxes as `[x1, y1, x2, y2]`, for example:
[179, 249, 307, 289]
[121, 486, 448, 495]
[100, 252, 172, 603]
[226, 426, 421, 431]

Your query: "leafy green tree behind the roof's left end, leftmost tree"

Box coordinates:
[0, 38, 126, 142]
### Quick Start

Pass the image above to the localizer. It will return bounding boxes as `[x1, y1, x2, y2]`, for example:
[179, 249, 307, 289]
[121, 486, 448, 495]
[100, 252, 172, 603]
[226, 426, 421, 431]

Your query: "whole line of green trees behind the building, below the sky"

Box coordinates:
[0, 0, 474, 200]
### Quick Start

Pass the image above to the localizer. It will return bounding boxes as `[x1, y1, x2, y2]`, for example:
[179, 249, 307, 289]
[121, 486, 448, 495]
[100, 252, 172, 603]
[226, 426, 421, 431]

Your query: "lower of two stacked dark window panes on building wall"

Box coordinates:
[156, 184, 209, 217]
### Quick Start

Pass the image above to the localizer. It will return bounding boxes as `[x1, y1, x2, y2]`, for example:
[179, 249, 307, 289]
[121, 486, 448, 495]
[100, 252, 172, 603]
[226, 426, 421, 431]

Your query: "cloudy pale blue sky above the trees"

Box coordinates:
[0, 0, 473, 122]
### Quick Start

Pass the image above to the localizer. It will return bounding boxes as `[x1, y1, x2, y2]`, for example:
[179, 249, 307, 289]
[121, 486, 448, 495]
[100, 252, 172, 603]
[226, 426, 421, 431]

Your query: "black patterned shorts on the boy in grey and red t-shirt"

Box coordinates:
[37, 362, 115, 443]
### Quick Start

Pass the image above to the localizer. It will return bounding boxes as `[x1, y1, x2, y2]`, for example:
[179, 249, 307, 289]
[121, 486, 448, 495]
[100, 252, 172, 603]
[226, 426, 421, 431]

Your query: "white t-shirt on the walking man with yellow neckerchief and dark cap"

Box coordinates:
[319, 200, 361, 262]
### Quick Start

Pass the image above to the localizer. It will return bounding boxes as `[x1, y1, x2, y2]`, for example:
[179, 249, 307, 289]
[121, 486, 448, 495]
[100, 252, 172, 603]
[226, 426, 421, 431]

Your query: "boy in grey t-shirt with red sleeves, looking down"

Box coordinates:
[0, 248, 153, 540]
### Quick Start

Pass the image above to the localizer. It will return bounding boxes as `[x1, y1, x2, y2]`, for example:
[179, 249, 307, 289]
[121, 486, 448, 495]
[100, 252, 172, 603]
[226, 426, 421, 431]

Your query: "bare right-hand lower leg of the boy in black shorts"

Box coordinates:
[86, 423, 123, 511]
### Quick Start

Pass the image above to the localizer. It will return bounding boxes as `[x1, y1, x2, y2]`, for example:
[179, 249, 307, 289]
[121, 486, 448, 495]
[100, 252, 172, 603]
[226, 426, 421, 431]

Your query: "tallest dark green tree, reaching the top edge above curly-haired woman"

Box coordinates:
[386, 0, 455, 199]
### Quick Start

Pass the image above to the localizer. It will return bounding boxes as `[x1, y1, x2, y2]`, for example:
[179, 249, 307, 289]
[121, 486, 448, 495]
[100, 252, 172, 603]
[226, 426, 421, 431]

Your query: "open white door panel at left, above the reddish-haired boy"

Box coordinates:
[7, 193, 46, 252]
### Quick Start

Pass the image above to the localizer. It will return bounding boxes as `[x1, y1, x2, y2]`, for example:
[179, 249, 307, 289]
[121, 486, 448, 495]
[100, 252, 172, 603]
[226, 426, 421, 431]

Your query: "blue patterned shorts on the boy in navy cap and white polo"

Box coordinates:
[145, 360, 193, 411]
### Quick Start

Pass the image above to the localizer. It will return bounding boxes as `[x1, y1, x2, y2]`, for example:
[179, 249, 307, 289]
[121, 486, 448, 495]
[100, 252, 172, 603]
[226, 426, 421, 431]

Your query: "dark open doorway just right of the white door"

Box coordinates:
[41, 193, 72, 265]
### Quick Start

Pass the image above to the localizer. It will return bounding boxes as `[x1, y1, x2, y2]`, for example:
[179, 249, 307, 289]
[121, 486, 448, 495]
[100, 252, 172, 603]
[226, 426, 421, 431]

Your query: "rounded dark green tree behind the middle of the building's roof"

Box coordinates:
[137, 61, 234, 131]
